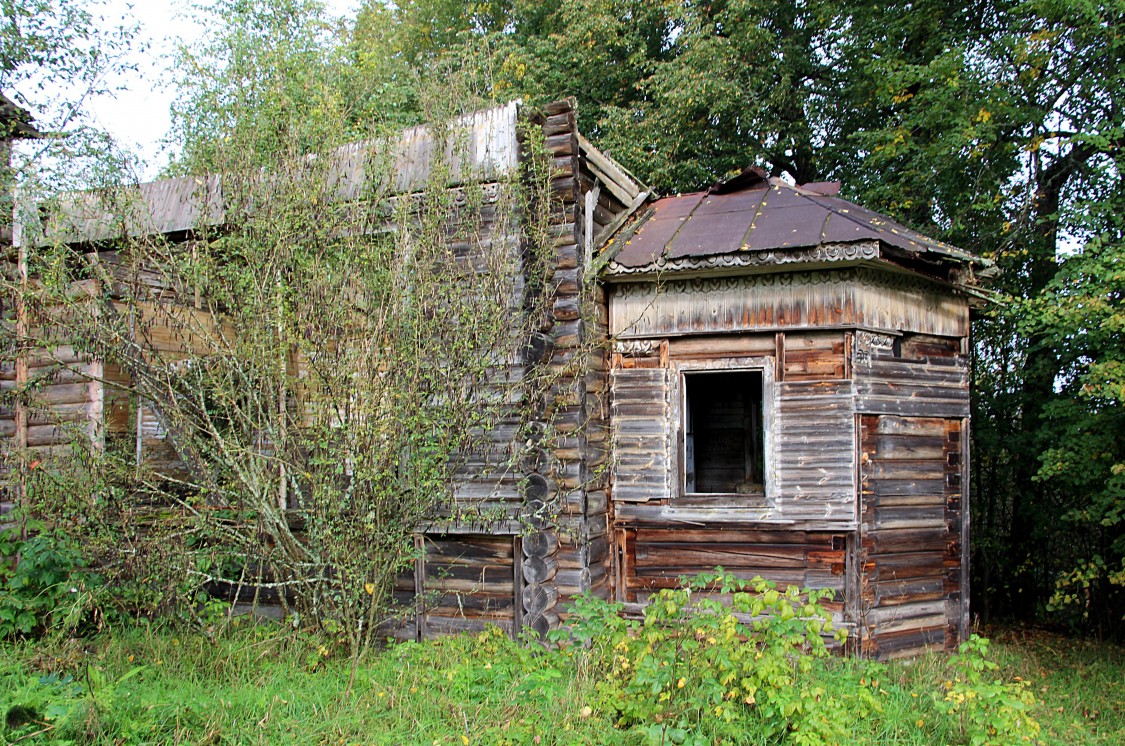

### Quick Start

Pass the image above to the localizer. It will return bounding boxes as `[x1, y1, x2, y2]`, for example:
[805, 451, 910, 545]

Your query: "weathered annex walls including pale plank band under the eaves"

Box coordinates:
[611, 270, 969, 658]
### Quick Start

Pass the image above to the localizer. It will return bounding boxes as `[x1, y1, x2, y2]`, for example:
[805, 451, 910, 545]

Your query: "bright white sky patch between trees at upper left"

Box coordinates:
[89, 0, 360, 180]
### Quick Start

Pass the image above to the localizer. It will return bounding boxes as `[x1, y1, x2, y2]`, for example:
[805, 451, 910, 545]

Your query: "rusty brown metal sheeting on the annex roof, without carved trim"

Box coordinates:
[611, 169, 988, 273]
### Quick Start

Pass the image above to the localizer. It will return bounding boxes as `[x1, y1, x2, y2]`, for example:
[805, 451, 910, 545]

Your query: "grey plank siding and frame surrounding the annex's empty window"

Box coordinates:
[612, 331, 856, 530]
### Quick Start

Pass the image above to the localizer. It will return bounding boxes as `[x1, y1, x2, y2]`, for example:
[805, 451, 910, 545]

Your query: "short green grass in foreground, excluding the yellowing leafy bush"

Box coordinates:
[0, 624, 1125, 746]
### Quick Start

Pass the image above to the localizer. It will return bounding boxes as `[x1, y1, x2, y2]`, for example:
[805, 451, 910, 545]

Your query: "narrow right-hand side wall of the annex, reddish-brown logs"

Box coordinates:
[854, 332, 969, 658]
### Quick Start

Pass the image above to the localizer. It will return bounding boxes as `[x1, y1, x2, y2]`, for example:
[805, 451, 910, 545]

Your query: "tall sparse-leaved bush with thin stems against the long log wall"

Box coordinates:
[10, 91, 562, 650]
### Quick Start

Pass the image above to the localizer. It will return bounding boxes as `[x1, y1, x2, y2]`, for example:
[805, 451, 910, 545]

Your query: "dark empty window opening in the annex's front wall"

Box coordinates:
[684, 370, 765, 494]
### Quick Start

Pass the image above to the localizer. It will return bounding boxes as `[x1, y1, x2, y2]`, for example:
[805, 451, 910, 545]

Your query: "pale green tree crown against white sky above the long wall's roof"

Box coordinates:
[171, 0, 370, 173]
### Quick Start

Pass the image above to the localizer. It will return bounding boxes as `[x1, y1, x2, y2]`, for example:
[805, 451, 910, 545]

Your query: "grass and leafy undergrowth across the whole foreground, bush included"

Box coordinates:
[8, 577, 1125, 745]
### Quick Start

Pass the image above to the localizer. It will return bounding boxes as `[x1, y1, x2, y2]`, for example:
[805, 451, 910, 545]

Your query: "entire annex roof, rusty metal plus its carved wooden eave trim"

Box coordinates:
[599, 169, 996, 302]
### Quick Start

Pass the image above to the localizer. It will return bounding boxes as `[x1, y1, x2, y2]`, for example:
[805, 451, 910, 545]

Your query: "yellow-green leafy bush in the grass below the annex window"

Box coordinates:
[556, 568, 855, 744]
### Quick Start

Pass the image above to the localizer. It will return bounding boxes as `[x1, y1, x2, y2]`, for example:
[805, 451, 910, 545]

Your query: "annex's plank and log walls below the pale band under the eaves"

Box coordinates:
[612, 321, 969, 657]
